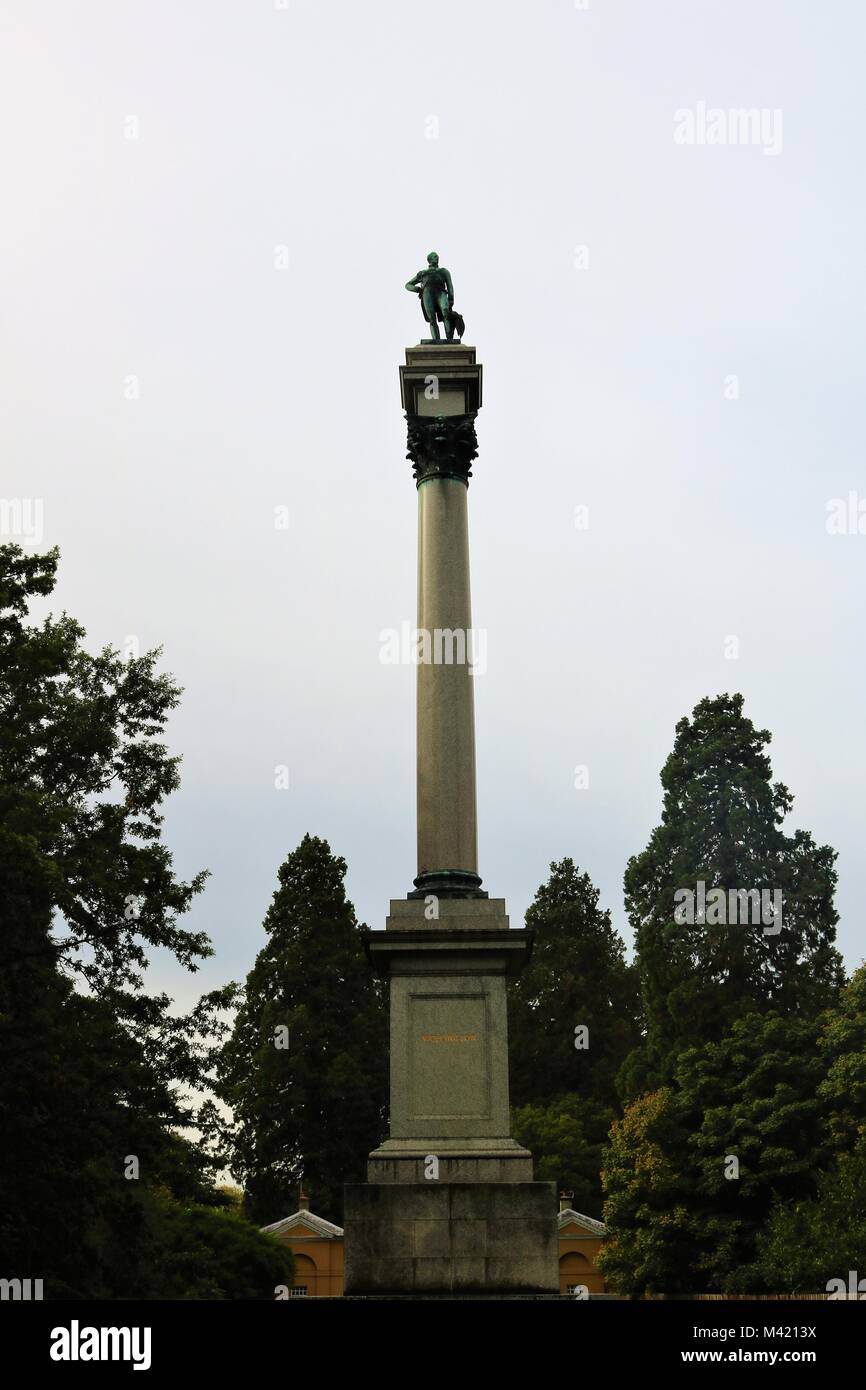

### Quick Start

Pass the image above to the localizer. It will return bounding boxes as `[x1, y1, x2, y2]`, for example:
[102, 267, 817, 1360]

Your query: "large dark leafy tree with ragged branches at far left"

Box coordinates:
[0, 545, 232, 1298]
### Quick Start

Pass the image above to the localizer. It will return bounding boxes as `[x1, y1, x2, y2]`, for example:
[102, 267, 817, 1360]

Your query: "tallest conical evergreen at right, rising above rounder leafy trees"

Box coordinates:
[624, 695, 844, 1095]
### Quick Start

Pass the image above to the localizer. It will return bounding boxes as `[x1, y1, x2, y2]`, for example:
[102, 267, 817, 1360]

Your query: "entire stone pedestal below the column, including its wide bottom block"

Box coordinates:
[343, 898, 559, 1294]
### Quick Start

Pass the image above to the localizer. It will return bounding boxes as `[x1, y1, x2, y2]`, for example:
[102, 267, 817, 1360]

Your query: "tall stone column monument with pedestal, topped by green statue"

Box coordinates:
[345, 309, 559, 1295]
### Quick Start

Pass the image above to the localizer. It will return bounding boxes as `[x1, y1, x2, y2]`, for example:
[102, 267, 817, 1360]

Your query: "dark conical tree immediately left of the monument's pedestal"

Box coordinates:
[220, 835, 388, 1225]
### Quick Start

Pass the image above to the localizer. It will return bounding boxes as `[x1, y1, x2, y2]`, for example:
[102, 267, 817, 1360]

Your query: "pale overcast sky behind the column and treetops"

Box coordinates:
[0, 0, 866, 1002]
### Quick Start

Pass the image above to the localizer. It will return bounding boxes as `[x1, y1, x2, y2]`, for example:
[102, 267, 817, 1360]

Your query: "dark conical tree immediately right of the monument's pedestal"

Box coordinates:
[509, 859, 639, 1108]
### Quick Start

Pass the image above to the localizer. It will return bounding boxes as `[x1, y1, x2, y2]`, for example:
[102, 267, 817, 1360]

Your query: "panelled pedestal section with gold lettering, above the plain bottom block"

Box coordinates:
[367, 898, 532, 1183]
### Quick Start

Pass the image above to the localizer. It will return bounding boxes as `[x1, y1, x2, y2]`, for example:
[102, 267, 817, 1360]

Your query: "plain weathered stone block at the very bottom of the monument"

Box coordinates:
[345, 1182, 559, 1297]
